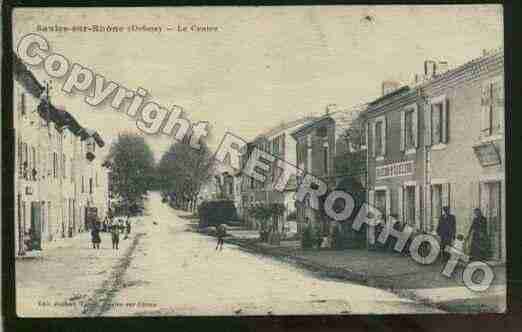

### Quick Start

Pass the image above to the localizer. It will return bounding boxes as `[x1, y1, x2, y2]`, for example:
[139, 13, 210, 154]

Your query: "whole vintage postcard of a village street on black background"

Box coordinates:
[10, 5, 502, 317]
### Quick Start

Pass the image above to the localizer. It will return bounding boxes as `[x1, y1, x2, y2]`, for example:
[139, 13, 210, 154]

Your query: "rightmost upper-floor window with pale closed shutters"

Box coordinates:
[481, 78, 504, 136]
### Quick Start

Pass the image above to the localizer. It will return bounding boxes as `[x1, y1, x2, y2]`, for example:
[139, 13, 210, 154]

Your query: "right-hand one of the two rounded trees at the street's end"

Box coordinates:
[156, 142, 214, 211]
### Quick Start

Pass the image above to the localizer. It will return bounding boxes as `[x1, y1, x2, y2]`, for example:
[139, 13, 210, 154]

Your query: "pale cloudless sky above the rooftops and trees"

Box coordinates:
[13, 5, 503, 159]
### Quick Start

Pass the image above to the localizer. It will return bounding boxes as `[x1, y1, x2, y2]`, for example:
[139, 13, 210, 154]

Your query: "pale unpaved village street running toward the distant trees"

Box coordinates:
[16, 192, 435, 316]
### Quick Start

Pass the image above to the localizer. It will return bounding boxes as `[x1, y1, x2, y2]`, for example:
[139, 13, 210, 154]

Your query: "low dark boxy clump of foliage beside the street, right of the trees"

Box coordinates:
[198, 200, 238, 227]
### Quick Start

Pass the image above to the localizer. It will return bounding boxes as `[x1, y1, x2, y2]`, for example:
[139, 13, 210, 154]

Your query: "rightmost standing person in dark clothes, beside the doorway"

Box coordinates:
[467, 208, 490, 261]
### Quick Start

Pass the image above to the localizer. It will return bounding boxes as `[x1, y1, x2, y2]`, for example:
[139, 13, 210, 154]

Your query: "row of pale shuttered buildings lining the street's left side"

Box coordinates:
[13, 56, 108, 256]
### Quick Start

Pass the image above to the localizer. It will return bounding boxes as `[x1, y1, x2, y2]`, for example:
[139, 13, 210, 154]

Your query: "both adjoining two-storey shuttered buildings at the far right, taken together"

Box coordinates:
[366, 50, 506, 261]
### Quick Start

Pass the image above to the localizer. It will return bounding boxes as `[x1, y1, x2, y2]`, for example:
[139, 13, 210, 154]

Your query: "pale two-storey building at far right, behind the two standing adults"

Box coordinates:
[419, 50, 506, 261]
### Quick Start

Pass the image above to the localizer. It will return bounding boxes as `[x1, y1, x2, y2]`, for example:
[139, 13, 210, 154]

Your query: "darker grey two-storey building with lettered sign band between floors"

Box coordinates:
[366, 86, 425, 229]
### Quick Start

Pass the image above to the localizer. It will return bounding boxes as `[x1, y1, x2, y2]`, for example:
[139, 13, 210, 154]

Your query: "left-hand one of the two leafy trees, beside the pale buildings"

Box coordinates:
[106, 134, 154, 214]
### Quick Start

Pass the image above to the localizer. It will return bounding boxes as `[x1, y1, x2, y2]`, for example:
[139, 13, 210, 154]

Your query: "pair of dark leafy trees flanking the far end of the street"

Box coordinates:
[105, 133, 213, 215]
